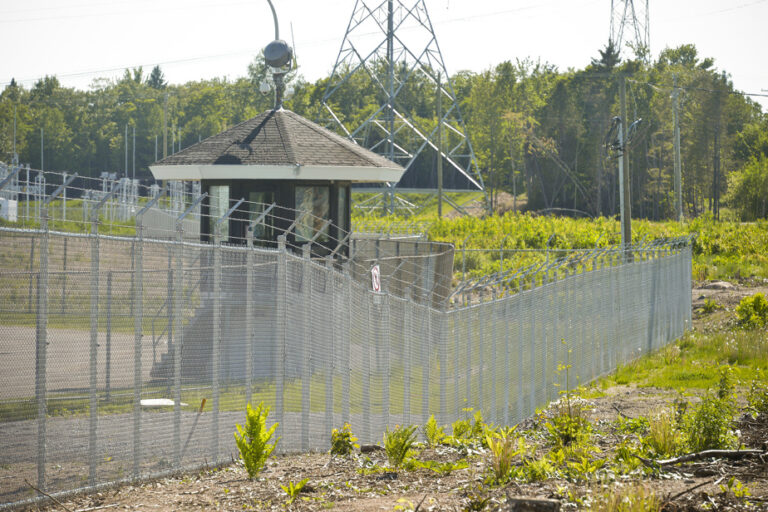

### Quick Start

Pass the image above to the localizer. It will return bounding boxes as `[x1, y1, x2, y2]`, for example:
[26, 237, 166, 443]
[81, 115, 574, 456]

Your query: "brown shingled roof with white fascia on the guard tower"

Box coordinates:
[150, 109, 404, 181]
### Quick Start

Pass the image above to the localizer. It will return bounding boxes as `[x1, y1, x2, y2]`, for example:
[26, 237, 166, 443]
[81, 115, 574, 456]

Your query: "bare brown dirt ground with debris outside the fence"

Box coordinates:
[18, 282, 768, 512]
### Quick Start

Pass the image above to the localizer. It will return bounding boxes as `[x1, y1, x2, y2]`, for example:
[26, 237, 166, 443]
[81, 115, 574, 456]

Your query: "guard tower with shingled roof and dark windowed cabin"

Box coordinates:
[150, 109, 404, 254]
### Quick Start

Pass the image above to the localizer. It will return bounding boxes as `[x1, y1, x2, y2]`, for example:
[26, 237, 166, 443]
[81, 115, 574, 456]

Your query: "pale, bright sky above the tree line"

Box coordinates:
[0, 0, 768, 111]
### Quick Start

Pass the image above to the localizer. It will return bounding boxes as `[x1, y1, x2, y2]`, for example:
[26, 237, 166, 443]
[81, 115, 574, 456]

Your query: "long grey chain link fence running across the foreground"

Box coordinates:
[0, 192, 691, 508]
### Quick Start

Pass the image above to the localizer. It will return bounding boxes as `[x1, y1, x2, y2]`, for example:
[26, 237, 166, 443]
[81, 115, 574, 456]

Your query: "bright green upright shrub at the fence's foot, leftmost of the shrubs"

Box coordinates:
[235, 402, 280, 478]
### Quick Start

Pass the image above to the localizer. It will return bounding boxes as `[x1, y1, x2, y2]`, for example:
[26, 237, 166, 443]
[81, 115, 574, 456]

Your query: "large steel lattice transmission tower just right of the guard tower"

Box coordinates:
[323, 0, 484, 212]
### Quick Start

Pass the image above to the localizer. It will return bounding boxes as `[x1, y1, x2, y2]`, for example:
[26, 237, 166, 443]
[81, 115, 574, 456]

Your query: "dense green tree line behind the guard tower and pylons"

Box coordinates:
[0, 43, 768, 220]
